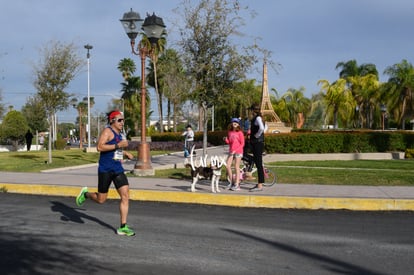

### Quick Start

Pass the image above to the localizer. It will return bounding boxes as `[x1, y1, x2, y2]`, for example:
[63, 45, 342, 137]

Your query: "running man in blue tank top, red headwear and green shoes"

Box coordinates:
[76, 110, 135, 236]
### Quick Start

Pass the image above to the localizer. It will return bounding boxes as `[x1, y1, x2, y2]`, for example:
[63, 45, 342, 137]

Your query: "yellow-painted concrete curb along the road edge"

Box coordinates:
[0, 183, 414, 211]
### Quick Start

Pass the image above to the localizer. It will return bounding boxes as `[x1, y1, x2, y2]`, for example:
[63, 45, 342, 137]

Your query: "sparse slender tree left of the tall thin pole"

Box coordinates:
[33, 41, 84, 163]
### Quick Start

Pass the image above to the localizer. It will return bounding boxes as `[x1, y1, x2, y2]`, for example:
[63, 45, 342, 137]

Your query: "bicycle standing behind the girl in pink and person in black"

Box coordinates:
[227, 155, 277, 187]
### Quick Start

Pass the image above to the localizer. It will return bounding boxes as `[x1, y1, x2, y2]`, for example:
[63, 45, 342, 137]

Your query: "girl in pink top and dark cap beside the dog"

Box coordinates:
[224, 118, 244, 191]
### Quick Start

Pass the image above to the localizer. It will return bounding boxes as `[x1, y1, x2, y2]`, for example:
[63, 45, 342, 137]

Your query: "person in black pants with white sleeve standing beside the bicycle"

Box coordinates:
[249, 104, 265, 192]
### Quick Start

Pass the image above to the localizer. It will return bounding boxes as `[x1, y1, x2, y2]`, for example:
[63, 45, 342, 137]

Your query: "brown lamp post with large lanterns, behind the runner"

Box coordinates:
[120, 9, 165, 176]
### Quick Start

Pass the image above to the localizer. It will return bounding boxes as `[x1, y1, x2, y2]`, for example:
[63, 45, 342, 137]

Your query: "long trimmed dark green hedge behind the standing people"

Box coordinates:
[151, 130, 414, 154]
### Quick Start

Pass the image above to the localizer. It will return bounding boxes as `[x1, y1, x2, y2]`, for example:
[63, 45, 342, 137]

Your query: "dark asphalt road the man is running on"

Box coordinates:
[0, 193, 414, 275]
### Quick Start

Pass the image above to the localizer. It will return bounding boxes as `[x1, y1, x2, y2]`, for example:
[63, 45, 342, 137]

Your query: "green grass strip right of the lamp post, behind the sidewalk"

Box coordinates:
[155, 160, 414, 186]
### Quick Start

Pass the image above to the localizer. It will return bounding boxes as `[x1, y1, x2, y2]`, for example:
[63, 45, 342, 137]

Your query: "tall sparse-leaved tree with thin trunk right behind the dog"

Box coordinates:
[177, 0, 256, 154]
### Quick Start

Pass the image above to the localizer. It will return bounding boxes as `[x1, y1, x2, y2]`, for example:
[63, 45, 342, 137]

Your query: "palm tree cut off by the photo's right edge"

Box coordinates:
[384, 59, 414, 129]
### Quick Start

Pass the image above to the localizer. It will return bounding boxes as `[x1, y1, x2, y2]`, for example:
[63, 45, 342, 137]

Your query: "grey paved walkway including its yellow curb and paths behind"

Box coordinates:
[0, 146, 414, 211]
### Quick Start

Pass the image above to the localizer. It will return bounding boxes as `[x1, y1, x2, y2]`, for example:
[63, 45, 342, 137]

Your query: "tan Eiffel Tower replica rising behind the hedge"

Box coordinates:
[260, 61, 292, 133]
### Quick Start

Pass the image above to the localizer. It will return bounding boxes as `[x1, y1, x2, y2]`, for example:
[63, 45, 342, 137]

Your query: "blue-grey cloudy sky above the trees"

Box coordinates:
[0, 0, 414, 122]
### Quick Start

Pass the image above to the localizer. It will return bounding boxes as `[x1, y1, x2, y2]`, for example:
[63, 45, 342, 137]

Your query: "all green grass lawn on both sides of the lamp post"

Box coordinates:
[0, 149, 414, 186]
